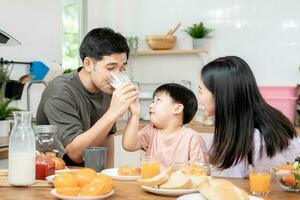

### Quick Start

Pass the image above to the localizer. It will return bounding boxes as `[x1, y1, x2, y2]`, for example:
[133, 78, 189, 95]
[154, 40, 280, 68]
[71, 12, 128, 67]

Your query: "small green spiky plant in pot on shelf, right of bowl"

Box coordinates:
[184, 22, 213, 49]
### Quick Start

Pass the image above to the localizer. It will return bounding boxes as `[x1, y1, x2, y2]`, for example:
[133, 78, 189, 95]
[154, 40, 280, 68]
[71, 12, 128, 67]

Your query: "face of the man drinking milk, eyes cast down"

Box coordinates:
[90, 53, 127, 94]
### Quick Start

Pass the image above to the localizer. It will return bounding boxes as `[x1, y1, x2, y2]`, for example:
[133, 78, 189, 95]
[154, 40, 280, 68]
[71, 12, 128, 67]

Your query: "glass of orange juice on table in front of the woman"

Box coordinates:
[249, 165, 271, 195]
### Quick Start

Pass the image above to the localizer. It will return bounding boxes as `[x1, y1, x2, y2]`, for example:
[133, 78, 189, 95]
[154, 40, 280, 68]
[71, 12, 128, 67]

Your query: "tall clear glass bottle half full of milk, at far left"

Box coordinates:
[8, 111, 35, 186]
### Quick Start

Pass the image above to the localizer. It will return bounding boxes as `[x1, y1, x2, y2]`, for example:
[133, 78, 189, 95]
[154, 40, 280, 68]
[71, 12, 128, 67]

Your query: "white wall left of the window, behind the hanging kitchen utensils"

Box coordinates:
[0, 0, 62, 114]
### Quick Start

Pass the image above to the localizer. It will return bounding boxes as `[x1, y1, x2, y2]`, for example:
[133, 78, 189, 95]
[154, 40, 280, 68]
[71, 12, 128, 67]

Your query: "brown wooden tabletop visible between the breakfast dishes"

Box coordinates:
[0, 179, 300, 200]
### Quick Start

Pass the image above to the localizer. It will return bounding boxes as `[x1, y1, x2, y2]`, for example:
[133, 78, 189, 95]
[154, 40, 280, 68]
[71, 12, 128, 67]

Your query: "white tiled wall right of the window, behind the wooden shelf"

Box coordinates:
[88, 0, 300, 85]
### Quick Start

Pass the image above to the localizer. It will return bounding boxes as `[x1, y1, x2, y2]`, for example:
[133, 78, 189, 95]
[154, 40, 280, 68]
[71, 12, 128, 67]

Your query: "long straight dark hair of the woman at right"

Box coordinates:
[201, 56, 296, 169]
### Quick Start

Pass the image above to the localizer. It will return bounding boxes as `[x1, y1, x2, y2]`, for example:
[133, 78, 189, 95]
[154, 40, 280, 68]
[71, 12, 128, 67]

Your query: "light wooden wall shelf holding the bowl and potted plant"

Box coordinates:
[130, 49, 207, 56]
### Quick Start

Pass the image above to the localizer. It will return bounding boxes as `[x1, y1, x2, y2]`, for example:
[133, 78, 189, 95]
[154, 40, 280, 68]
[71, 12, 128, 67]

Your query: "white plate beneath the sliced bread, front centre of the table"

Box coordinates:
[142, 185, 198, 196]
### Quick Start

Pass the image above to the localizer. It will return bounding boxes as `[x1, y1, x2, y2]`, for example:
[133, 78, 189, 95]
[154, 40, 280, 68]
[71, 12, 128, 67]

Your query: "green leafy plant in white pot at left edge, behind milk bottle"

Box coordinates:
[0, 97, 20, 137]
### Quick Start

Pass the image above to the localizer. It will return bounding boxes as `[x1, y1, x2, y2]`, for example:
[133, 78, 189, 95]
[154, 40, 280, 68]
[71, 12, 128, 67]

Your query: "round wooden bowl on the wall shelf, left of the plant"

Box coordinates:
[146, 35, 176, 50]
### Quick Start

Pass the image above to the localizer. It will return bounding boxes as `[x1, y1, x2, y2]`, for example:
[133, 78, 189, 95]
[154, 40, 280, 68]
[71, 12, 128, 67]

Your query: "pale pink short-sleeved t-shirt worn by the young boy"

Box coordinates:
[138, 124, 208, 169]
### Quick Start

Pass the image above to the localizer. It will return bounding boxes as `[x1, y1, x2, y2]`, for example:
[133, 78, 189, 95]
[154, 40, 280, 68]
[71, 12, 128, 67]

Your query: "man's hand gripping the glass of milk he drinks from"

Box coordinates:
[108, 82, 139, 119]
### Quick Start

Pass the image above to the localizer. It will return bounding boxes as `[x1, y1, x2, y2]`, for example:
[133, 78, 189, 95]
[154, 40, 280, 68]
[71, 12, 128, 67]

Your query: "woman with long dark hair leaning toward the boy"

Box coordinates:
[199, 56, 300, 178]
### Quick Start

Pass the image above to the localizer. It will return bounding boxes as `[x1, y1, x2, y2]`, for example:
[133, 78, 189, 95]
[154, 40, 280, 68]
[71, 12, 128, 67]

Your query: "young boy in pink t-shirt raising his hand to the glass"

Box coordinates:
[122, 83, 207, 169]
